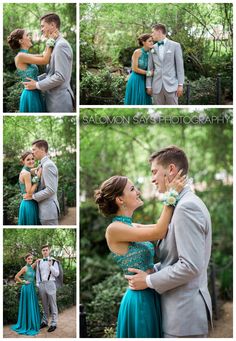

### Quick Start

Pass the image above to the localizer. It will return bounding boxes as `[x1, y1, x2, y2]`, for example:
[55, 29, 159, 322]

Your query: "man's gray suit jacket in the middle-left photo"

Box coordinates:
[33, 156, 60, 220]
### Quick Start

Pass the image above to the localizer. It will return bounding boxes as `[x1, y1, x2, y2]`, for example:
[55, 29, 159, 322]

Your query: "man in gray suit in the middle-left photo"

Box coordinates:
[24, 140, 60, 226]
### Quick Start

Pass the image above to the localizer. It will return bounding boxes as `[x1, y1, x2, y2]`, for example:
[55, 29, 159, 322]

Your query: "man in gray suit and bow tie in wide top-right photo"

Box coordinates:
[146, 24, 184, 105]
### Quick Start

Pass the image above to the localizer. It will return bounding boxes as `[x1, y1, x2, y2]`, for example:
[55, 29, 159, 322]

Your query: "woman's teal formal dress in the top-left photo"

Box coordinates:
[17, 50, 46, 112]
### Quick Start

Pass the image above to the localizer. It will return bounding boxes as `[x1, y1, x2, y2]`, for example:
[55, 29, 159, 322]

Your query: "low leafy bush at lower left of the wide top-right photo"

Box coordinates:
[80, 69, 126, 104]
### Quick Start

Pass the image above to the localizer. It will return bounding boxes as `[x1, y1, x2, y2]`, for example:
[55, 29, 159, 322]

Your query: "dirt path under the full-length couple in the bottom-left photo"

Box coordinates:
[3, 306, 76, 338]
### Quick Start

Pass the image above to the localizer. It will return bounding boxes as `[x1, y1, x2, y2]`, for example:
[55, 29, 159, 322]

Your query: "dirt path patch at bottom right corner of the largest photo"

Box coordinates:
[208, 302, 233, 338]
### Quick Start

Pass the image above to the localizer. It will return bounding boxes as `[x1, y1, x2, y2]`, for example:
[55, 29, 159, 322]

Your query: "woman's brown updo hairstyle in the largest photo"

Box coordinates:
[94, 175, 128, 216]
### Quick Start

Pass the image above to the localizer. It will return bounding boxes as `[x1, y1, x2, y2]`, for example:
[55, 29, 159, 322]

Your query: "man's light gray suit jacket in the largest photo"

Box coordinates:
[150, 186, 212, 336]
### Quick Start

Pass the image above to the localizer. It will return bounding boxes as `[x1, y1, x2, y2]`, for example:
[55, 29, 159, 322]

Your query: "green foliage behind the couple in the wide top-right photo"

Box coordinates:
[80, 3, 233, 104]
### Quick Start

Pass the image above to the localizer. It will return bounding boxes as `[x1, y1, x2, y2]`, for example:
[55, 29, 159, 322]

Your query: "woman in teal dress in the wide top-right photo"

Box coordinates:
[125, 33, 153, 105]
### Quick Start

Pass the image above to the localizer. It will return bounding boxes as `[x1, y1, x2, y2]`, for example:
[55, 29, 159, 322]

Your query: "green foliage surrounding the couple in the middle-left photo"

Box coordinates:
[3, 116, 76, 225]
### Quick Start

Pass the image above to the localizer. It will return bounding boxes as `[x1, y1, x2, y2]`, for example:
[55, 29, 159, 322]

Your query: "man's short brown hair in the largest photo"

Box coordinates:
[149, 146, 188, 175]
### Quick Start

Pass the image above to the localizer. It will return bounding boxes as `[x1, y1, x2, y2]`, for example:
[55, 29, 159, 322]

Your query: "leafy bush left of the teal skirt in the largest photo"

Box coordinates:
[87, 273, 127, 337]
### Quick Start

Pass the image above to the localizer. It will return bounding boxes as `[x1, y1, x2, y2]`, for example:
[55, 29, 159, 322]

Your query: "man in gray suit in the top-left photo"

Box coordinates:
[24, 13, 74, 113]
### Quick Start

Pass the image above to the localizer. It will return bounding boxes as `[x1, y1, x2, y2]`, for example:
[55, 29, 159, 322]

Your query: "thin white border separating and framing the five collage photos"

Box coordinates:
[0, 0, 236, 341]
